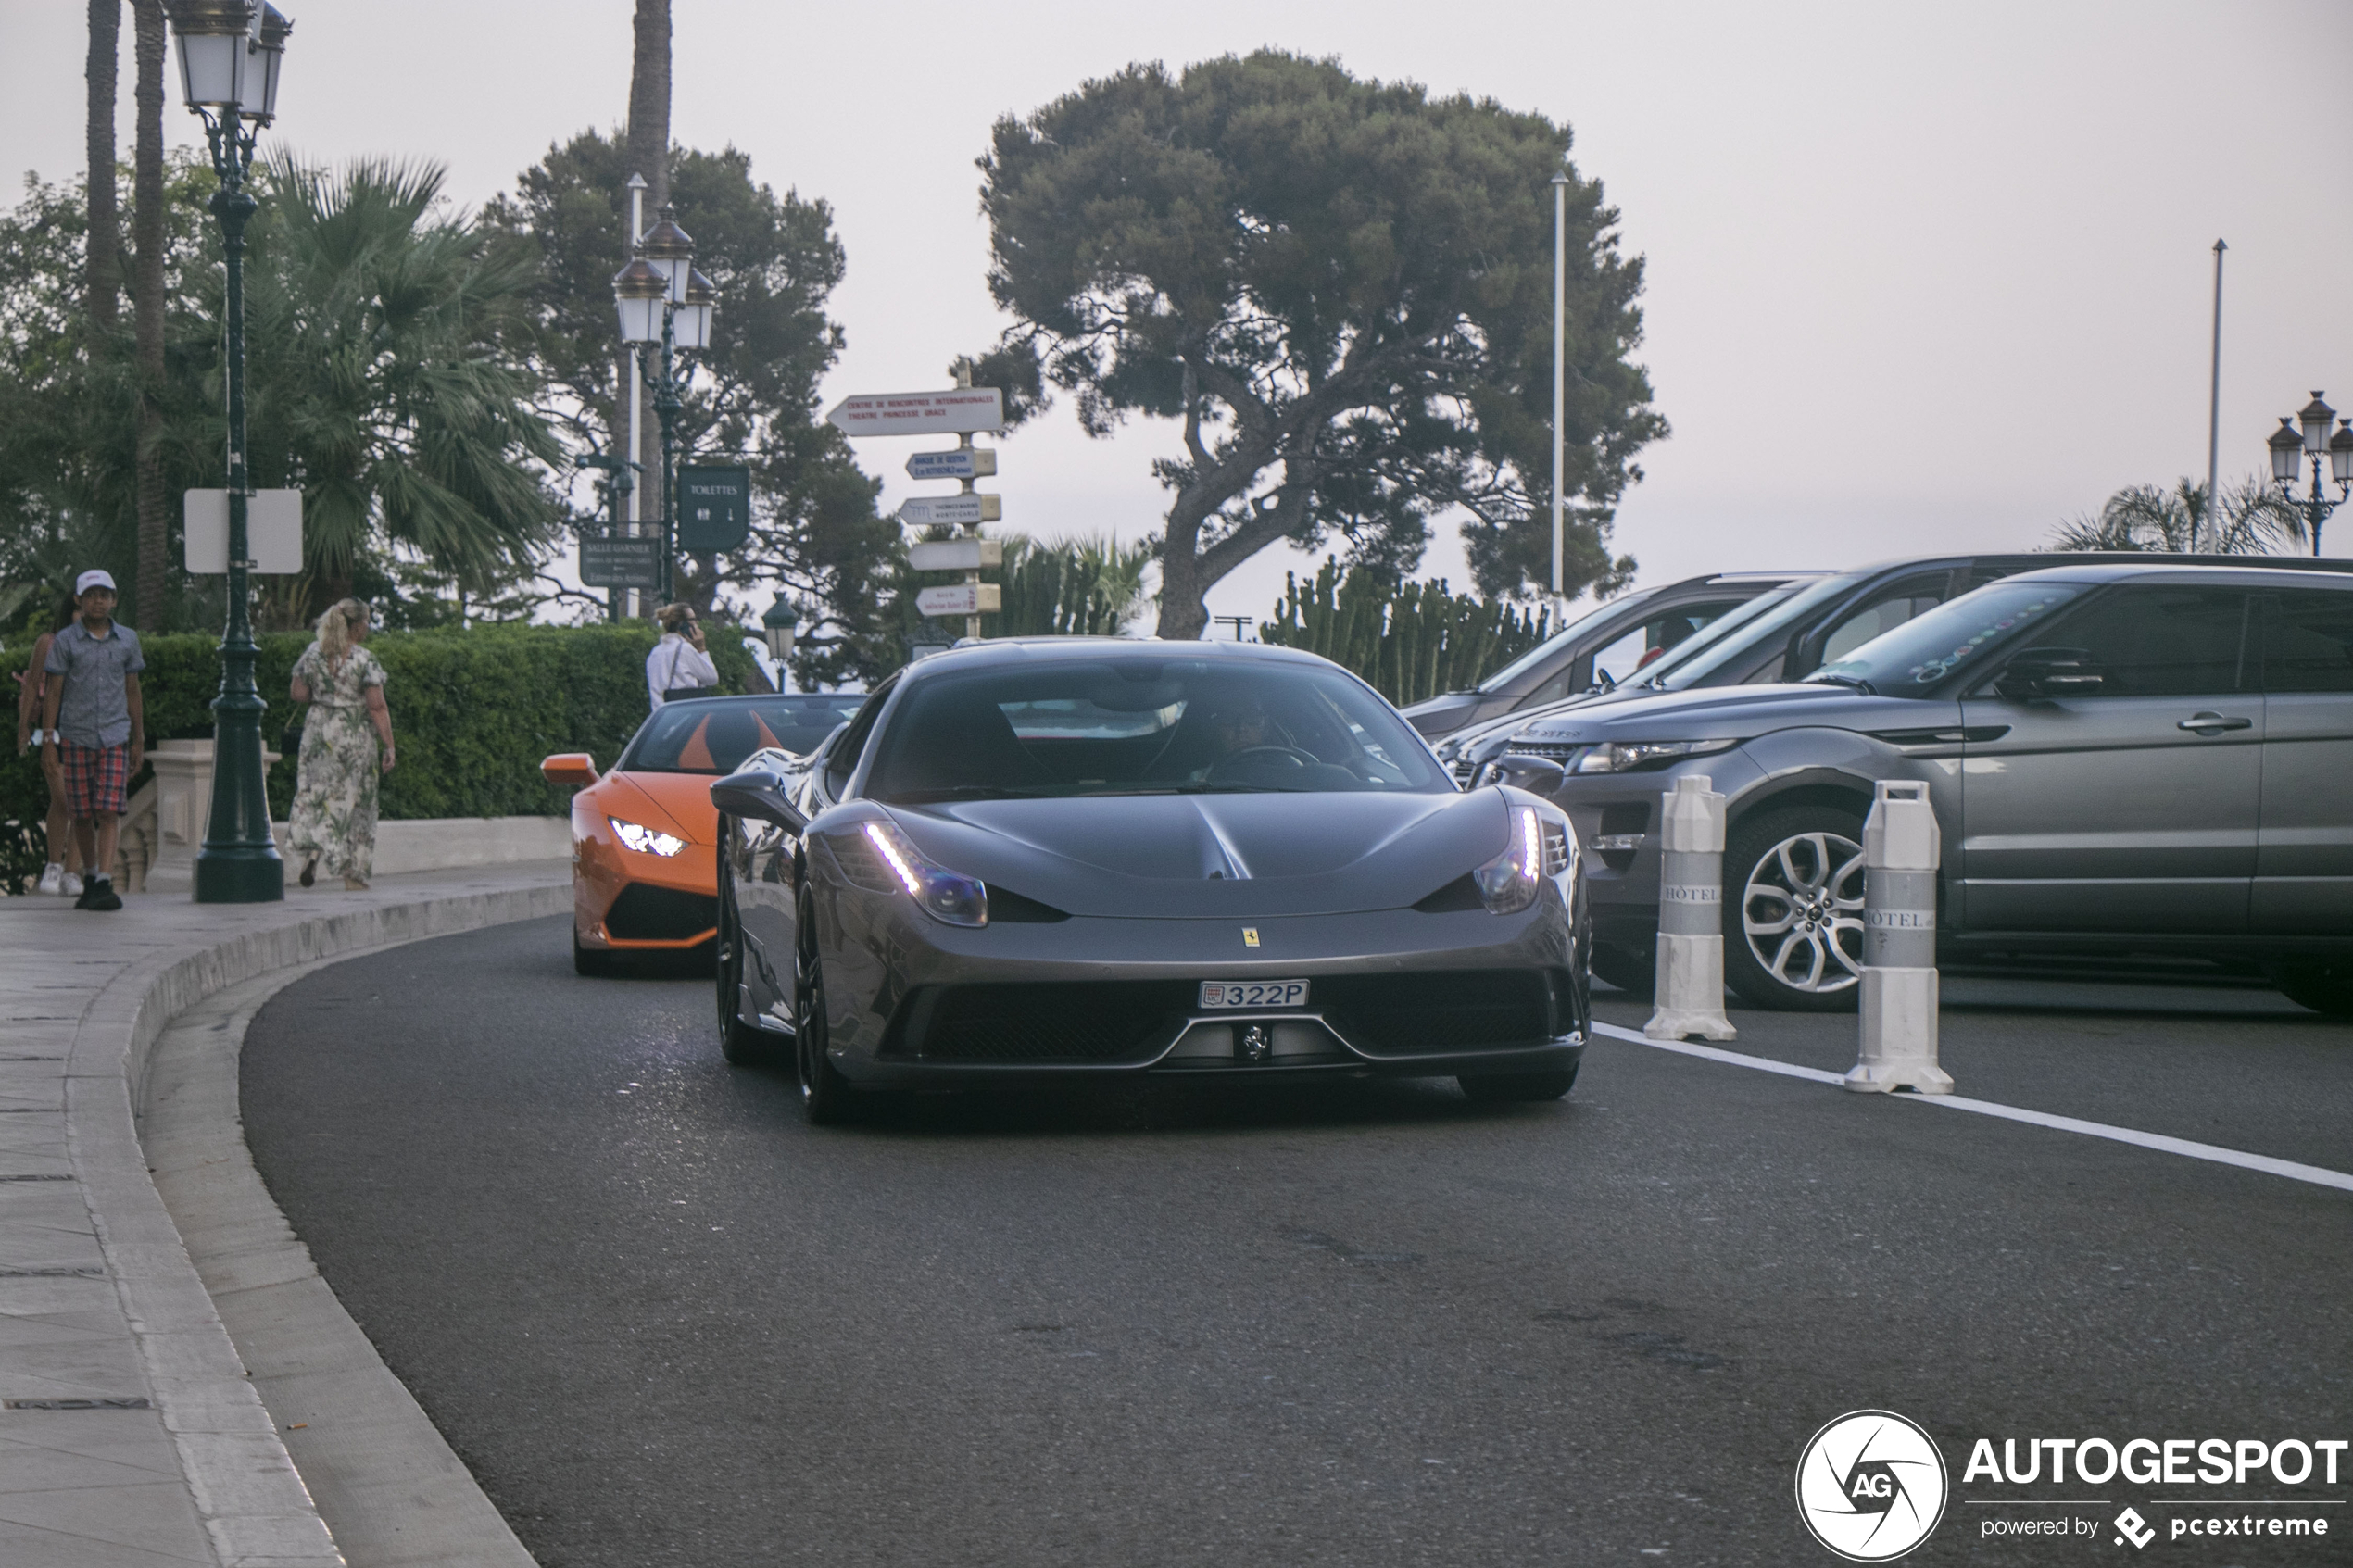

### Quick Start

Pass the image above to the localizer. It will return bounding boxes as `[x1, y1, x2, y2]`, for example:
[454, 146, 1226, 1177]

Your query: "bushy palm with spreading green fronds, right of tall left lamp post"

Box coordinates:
[247, 157, 560, 621]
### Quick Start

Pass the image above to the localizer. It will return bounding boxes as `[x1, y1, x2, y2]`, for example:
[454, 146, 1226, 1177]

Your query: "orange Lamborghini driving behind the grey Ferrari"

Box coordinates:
[539, 694, 866, 975]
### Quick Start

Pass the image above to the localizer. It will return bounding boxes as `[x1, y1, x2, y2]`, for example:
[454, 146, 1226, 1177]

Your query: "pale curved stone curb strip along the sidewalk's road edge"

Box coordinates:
[66, 882, 572, 1568]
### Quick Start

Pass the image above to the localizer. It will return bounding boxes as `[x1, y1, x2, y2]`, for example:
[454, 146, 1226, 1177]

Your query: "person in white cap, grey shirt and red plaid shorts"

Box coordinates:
[40, 571, 145, 909]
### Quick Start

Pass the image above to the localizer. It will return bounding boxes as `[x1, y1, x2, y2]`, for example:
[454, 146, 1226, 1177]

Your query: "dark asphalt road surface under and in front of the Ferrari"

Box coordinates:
[243, 919, 2353, 1568]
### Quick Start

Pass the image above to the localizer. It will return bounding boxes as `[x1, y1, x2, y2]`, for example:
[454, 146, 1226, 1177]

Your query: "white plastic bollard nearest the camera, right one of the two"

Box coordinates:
[1847, 778, 1953, 1096]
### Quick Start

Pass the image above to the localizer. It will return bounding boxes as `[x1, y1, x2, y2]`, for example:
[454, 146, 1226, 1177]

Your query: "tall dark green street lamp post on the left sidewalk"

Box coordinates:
[165, 0, 295, 903]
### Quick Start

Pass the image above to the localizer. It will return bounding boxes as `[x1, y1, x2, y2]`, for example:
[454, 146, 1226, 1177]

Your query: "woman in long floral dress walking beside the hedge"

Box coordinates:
[287, 599, 393, 894]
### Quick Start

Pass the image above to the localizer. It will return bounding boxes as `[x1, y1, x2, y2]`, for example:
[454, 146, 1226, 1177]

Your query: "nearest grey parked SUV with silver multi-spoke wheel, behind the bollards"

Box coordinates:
[1513, 559, 2353, 1013]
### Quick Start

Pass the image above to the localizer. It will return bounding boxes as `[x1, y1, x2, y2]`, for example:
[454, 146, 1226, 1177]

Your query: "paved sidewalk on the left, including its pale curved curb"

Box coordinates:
[0, 863, 570, 1568]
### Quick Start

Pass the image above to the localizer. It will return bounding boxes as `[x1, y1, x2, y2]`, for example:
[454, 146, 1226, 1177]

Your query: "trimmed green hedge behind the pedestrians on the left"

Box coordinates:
[0, 623, 753, 888]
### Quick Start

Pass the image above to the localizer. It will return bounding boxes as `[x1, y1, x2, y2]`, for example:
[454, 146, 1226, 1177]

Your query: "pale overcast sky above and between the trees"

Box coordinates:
[0, 0, 2353, 630]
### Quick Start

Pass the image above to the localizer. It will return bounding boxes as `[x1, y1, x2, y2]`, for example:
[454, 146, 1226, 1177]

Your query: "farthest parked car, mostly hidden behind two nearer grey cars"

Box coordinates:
[1404, 571, 1812, 741]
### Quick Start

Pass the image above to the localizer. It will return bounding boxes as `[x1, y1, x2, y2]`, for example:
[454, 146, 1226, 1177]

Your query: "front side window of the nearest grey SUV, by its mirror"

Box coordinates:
[2035, 583, 2254, 696]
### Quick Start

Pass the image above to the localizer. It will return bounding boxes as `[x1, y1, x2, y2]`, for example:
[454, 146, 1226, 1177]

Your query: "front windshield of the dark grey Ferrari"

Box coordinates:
[866, 656, 1454, 804]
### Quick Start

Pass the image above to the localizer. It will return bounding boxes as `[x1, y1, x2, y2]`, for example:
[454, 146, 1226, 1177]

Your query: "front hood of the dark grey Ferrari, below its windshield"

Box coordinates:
[889, 790, 1508, 919]
